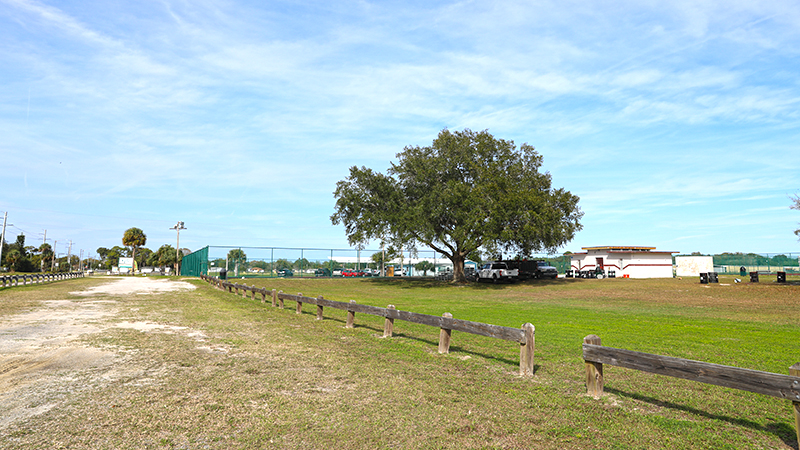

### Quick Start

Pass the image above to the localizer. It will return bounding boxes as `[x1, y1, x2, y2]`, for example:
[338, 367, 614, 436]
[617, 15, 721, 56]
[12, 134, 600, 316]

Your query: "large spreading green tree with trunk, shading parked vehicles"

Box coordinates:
[331, 129, 583, 281]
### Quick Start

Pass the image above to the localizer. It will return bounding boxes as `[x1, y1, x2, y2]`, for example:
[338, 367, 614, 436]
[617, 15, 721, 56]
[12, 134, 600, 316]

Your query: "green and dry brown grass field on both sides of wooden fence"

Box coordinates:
[0, 277, 800, 449]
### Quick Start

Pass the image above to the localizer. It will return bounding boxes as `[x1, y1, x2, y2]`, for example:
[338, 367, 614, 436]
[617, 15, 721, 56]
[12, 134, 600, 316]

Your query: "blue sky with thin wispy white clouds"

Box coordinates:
[0, 0, 800, 260]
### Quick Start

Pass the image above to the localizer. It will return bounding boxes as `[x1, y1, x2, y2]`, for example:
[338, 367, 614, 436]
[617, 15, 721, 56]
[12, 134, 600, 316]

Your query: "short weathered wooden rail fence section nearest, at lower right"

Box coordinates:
[583, 334, 800, 442]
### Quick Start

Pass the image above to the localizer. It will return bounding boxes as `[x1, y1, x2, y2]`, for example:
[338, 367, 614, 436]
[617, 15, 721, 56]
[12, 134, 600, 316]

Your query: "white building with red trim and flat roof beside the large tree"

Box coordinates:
[570, 246, 678, 278]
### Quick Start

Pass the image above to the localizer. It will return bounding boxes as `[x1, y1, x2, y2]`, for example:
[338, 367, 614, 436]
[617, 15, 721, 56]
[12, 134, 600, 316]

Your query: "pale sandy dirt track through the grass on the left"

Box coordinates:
[0, 277, 203, 436]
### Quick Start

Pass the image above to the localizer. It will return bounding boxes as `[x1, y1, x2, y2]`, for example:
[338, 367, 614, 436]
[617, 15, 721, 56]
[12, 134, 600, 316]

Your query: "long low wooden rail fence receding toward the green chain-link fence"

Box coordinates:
[201, 275, 536, 376]
